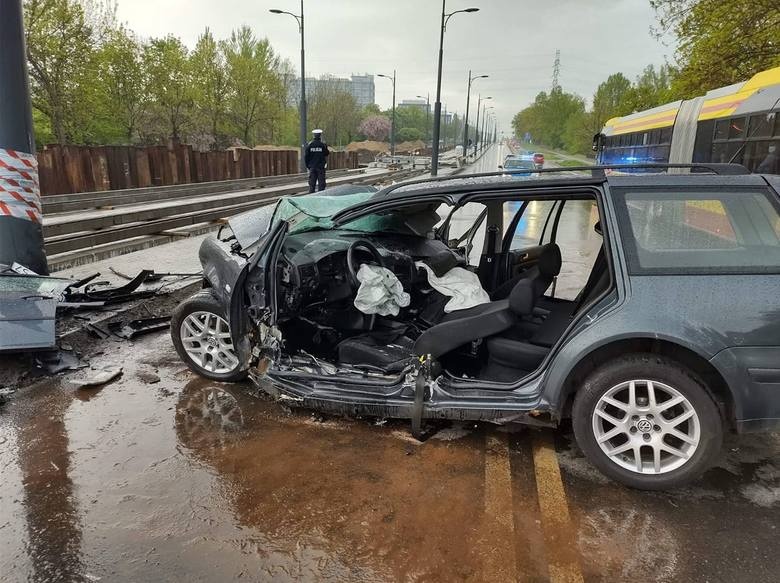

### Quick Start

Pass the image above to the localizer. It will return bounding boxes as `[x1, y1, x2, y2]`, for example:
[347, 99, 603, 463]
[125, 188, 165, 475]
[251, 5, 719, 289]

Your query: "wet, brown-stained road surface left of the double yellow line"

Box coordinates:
[0, 335, 508, 581]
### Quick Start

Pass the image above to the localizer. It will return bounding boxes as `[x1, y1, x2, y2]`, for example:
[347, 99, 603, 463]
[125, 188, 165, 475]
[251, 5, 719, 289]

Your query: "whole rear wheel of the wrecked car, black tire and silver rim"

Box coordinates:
[572, 354, 723, 490]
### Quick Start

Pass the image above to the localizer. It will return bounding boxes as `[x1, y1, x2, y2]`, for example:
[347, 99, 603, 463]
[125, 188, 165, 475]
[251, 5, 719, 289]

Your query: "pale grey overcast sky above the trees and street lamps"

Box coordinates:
[118, 0, 674, 129]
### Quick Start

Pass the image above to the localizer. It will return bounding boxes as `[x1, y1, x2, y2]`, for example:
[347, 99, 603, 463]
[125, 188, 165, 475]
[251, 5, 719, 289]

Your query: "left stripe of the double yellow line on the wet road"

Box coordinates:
[483, 431, 517, 581]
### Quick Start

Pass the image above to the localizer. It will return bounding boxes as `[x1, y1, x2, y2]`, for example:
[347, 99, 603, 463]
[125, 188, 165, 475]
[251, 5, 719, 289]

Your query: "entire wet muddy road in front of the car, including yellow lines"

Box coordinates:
[0, 333, 780, 583]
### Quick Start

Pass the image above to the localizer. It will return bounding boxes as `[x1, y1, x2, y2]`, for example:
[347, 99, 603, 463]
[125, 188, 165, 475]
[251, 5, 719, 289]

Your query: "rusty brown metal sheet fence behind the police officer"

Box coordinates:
[38, 145, 358, 196]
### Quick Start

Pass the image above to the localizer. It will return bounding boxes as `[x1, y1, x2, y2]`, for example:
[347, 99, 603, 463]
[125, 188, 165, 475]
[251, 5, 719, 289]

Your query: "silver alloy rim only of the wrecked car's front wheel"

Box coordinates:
[179, 311, 238, 374]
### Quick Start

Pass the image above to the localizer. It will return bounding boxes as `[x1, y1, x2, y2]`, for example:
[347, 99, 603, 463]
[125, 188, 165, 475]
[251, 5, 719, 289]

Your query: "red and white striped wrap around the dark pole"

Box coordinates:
[0, 148, 42, 223]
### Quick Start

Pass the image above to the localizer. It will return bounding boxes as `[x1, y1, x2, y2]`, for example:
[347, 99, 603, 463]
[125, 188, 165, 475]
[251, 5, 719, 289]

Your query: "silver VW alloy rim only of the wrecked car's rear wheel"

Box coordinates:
[592, 380, 701, 474]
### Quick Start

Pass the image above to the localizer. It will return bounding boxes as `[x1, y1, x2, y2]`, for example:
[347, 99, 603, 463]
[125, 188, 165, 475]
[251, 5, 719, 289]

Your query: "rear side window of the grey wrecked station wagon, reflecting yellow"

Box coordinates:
[617, 191, 780, 274]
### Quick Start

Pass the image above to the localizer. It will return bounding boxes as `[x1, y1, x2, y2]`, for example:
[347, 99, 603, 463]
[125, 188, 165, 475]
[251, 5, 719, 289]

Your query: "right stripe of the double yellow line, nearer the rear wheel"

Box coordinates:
[533, 432, 584, 583]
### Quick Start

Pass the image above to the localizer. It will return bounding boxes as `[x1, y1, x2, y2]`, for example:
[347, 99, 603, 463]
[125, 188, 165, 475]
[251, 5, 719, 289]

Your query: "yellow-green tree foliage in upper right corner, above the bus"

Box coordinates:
[650, 0, 780, 98]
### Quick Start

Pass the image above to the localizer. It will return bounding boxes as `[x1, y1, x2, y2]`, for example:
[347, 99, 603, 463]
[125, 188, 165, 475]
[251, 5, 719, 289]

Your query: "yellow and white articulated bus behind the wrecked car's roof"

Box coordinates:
[593, 67, 780, 174]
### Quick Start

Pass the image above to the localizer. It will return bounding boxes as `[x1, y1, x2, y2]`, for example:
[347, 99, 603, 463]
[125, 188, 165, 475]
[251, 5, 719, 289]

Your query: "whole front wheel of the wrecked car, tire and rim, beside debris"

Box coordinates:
[171, 290, 246, 382]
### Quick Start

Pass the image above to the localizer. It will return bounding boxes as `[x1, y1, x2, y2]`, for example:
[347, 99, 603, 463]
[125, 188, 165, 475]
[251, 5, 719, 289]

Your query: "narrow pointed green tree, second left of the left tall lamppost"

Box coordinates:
[190, 27, 230, 149]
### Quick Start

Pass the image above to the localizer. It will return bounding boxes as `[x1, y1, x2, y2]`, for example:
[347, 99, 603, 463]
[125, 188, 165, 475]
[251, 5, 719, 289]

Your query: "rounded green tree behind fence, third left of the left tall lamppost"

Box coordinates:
[143, 36, 193, 141]
